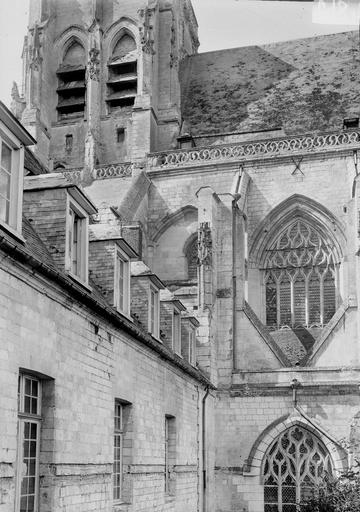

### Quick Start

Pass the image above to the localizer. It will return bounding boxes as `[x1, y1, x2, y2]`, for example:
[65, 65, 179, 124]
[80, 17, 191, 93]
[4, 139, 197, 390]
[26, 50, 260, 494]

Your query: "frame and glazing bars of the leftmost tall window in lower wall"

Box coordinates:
[15, 373, 42, 512]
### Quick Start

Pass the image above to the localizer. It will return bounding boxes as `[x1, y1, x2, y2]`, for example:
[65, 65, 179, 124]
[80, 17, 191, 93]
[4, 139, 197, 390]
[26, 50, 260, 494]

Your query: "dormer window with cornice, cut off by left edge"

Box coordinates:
[0, 102, 35, 235]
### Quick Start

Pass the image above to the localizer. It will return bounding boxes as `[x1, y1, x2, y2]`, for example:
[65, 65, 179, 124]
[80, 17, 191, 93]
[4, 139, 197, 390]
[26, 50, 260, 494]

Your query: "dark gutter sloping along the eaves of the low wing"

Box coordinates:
[0, 236, 216, 389]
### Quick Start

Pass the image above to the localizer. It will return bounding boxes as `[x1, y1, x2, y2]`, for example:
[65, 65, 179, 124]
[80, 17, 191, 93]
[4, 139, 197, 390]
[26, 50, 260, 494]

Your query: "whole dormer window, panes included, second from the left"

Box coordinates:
[66, 200, 88, 284]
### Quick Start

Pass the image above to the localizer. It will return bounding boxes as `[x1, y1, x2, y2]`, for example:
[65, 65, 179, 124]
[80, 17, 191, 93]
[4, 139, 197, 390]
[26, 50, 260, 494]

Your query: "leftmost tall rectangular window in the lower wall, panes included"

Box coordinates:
[16, 375, 41, 512]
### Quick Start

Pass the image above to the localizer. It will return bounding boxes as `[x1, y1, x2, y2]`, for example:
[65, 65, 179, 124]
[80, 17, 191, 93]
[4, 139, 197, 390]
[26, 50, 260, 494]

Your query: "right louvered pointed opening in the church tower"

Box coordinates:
[106, 34, 137, 111]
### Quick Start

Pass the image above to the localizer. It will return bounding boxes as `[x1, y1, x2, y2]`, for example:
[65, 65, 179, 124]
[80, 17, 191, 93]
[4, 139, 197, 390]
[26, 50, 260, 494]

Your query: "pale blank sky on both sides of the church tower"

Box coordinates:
[0, 0, 359, 105]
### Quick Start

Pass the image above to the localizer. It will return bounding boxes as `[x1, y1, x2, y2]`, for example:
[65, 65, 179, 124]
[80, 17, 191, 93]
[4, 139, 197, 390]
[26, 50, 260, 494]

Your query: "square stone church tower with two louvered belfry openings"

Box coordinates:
[13, 0, 199, 173]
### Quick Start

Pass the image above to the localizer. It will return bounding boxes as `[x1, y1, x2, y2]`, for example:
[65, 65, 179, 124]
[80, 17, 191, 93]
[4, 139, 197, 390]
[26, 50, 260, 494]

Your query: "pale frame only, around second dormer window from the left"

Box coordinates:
[65, 195, 89, 285]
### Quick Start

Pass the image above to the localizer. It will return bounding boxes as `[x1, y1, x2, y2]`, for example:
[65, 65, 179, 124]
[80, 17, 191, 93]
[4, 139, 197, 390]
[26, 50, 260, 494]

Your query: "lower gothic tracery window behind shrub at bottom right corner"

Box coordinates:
[264, 425, 332, 512]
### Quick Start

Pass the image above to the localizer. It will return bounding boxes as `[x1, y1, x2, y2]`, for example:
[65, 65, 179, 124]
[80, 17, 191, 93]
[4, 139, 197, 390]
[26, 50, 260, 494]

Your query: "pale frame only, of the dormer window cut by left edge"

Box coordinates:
[0, 122, 24, 238]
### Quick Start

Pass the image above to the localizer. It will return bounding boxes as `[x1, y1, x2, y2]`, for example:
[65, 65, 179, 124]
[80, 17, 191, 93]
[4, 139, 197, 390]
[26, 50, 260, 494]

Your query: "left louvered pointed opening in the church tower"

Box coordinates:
[56, 41, 86, 120]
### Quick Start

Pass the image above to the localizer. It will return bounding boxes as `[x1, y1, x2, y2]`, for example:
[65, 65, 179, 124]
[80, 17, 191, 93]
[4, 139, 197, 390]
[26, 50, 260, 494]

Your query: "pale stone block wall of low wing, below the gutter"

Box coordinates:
[0, 250, 208, 512]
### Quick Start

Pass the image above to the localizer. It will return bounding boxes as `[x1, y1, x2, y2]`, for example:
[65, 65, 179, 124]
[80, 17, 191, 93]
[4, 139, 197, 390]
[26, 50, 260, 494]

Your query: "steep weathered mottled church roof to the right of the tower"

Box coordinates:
[180, 32, 360, 135]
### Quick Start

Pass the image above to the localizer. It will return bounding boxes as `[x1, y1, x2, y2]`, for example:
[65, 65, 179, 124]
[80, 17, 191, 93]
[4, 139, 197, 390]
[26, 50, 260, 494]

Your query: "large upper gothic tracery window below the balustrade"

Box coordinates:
[265, 219, 337, 328]
